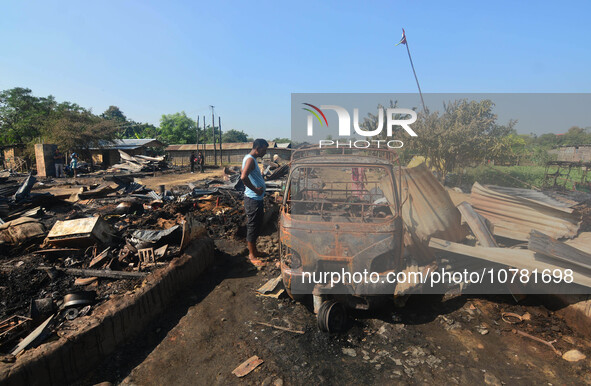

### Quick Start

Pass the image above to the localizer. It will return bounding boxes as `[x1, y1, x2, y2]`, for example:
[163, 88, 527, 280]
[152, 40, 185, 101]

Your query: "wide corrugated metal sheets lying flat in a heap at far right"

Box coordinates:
[470, 182, 581, 241]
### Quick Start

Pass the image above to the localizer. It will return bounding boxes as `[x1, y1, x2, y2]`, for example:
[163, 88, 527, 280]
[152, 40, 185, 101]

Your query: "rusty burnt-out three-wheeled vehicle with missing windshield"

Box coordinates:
[279, 148, 406, 332]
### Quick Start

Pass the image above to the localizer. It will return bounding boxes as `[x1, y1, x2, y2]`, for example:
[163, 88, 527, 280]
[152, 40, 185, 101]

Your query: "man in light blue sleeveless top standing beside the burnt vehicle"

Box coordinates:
[240, 138, 269, 265]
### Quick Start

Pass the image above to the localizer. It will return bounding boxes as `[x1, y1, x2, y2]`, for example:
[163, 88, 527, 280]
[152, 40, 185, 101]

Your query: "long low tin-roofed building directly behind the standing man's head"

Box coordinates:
[165, 141, 291, 166]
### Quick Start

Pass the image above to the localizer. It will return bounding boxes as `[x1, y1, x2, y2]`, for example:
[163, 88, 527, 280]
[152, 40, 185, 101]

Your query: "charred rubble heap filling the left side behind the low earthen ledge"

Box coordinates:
[0, 164, 278, 358]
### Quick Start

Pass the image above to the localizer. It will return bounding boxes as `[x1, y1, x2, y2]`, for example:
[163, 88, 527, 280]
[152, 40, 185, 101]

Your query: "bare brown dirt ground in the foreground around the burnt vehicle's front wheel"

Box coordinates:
[80, 235, 591, 385]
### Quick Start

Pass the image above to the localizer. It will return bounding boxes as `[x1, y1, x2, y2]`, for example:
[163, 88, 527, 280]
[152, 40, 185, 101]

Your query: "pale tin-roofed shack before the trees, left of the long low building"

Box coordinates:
[90, 138, 164, 167]
